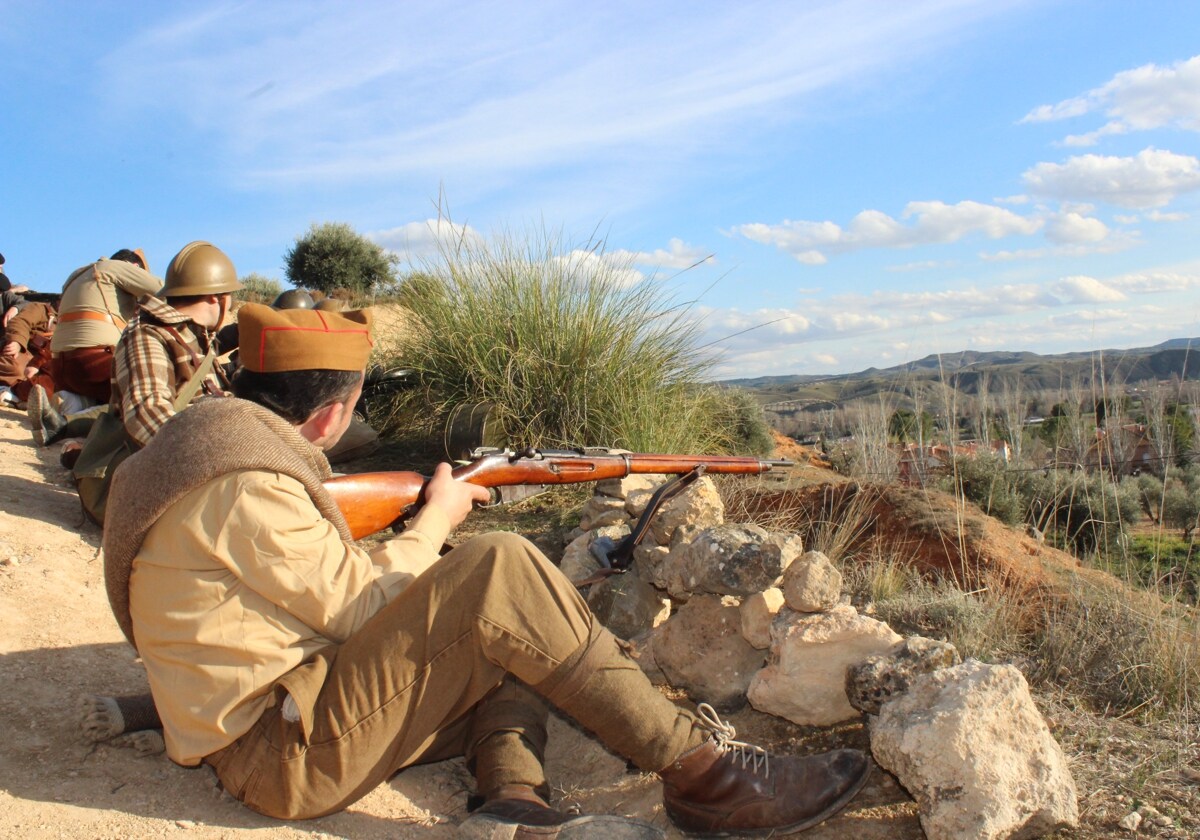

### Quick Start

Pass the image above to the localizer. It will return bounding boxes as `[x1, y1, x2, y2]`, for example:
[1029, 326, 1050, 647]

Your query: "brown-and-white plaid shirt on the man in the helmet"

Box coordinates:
[112, 295, 229, 449]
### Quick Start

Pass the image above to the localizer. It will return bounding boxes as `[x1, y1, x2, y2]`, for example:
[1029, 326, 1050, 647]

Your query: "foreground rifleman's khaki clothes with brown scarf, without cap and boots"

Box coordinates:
[104, 398, 703, 818]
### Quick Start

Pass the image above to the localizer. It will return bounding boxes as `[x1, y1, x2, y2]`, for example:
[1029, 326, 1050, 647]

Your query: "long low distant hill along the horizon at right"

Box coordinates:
[721, 338, 1200, 408]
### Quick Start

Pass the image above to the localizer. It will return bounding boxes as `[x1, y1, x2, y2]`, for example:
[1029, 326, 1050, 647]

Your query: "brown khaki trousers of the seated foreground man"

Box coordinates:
[205, 533, 695, 818]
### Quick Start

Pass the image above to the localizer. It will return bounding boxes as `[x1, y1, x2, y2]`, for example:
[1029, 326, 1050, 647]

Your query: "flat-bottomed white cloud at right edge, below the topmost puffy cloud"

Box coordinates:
[1022, 149, 1200, 210]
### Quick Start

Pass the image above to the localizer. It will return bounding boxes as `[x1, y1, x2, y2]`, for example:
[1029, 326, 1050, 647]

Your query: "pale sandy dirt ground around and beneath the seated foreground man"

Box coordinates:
[0, 408, 923, 840]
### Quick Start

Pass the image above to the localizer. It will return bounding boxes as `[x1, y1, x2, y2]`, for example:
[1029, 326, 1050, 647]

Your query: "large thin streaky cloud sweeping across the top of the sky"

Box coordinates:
[97, 0, 998, 181]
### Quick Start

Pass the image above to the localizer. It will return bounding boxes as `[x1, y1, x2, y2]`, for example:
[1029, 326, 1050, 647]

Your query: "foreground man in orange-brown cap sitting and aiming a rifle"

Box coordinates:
[104, 305, 870, 838]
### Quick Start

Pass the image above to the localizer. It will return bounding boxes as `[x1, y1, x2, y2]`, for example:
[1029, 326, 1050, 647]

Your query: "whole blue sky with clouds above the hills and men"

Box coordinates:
[0, 0, 1200, 377]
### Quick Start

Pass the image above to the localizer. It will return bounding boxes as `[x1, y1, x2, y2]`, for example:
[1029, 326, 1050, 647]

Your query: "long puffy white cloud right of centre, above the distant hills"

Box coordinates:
[733, 200, 1042, 265]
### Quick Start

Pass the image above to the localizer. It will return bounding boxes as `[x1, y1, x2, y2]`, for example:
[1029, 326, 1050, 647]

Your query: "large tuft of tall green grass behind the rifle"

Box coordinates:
[376, 228, 766, 452]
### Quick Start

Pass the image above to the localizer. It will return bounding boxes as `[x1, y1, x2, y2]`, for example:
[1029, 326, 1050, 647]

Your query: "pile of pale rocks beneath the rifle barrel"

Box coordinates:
[560, 476, 1079, 840]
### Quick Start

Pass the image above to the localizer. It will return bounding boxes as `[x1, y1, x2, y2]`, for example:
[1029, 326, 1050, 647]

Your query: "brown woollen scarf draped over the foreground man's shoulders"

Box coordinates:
[103, 397, 350, 647]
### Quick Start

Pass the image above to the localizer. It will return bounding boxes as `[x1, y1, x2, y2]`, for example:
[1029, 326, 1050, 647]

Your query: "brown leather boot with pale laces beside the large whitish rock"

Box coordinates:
[659, 703, 871, 836]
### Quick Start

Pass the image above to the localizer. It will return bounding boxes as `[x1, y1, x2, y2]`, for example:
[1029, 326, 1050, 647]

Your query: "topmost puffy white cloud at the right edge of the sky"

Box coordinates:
[1020, 55, 1200, 145]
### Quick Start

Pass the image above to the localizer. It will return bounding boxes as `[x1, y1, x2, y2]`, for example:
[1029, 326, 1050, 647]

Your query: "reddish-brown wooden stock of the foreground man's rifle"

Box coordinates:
[325, 450, 792, 539]
